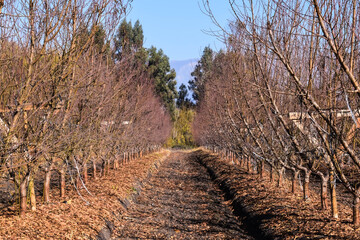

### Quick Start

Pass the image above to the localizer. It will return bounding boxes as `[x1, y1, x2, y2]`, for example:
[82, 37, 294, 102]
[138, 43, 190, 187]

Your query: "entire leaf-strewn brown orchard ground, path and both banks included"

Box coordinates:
[0, 150, 360, 239]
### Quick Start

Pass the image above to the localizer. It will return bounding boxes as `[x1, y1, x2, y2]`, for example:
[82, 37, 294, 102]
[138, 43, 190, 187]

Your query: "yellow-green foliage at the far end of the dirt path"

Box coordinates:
[167, 108, 195, 147]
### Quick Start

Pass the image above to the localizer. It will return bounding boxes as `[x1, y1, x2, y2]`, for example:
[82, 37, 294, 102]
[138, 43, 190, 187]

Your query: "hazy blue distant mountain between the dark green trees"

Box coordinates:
[170, 59, 198, 90]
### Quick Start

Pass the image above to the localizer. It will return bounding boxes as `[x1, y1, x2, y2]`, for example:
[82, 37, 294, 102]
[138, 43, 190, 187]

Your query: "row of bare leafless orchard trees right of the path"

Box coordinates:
[192, 0, 360, 226]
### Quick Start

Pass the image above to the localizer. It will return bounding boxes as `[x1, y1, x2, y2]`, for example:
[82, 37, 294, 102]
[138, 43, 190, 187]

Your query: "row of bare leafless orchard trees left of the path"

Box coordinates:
[0, 0, 171, 215]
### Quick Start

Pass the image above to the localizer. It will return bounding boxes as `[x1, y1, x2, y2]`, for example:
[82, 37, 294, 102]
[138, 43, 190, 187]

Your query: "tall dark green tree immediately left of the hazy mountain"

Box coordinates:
[148, 47, 178, 120]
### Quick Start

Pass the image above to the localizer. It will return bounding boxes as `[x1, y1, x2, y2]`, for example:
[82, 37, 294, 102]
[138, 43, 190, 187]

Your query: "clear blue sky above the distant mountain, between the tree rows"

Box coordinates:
[127, 0, 231, 61]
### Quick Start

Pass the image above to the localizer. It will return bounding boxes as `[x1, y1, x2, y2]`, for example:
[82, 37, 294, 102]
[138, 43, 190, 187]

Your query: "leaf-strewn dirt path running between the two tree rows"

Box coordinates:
[113, 151, 253, 239]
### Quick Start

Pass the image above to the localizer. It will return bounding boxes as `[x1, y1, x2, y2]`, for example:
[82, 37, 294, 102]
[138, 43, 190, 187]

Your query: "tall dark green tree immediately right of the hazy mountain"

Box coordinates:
[189, 47, 215, 103]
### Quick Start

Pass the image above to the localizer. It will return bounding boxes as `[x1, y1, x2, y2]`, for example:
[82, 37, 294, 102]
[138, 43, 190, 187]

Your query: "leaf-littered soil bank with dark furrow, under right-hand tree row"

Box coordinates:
[193, 150, 360, 239]
